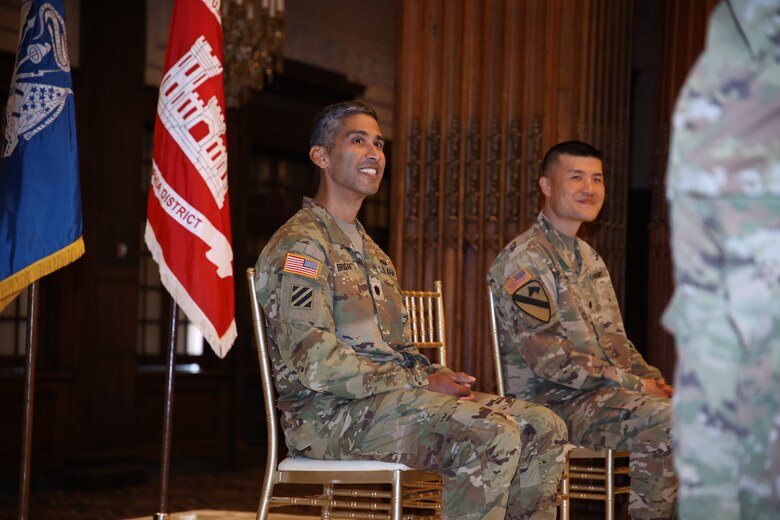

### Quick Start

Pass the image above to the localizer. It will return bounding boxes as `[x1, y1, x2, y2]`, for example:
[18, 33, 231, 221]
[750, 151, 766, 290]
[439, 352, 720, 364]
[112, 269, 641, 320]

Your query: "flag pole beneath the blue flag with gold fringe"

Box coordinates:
[19, 280, 38, 520]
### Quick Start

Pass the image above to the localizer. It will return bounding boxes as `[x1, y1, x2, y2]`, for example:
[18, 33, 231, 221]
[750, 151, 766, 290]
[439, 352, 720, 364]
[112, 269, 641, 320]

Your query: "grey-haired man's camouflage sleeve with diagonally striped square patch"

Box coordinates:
[261, 243, 428, 399]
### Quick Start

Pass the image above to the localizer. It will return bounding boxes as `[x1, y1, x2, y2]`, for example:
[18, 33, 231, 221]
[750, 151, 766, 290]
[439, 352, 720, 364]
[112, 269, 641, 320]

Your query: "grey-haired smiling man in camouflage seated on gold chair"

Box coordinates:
[257, 102, 566, 520]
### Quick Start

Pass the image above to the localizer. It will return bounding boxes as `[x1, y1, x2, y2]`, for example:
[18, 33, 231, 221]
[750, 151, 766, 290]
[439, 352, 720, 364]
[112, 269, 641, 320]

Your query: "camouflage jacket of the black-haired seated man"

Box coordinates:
[488, 213, 661, 402]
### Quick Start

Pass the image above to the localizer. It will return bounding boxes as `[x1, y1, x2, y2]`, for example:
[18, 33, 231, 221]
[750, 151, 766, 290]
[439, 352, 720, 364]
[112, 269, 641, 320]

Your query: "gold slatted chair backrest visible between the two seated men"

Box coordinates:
[402, 280, 447, 366]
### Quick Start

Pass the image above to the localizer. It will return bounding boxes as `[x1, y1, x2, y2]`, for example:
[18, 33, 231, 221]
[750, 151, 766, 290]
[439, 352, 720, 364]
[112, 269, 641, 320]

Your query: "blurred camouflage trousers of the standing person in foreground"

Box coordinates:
[663, 194, 780, 520]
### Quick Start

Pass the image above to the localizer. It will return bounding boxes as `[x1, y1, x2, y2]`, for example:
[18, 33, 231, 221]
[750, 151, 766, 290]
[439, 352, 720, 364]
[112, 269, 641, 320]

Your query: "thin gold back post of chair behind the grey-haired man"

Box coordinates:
[246, 267, 279, 468]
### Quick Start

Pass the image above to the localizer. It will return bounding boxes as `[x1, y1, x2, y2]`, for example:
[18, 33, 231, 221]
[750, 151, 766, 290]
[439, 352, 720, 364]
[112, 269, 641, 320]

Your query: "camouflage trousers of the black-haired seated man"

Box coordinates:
[536, 387, 677, 519]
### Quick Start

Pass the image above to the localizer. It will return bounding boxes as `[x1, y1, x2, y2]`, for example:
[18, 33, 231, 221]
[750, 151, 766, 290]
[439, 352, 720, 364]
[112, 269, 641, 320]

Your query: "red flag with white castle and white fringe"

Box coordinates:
[145, 0, 236, 357]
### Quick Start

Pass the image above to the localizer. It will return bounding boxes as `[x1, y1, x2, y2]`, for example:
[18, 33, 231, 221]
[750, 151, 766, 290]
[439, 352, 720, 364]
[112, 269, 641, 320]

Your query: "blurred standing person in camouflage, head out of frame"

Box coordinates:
[663, 0, 780, 520]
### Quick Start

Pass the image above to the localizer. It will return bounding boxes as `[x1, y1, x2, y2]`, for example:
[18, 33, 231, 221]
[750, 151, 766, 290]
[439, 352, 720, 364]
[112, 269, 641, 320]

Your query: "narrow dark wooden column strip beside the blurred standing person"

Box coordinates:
[647, 0, 717, 378]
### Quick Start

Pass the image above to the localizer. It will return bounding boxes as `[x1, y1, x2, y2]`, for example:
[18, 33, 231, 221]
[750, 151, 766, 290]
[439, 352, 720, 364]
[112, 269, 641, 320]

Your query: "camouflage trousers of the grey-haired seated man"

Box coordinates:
[298, 388, 566, 520]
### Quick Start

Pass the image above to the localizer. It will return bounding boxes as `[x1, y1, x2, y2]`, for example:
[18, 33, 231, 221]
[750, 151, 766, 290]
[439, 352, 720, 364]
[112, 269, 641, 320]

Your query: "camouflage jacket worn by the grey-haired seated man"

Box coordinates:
[256, 198, 442, 453]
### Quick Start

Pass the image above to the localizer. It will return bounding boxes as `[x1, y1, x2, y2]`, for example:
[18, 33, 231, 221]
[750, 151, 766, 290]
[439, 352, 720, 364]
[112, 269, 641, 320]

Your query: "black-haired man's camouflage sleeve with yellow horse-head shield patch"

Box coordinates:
[490, 252, 642, 390]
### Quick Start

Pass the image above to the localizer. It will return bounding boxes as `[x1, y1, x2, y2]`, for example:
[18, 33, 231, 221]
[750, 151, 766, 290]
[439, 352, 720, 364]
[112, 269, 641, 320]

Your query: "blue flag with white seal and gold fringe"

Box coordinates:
[0, 0, 84, 311]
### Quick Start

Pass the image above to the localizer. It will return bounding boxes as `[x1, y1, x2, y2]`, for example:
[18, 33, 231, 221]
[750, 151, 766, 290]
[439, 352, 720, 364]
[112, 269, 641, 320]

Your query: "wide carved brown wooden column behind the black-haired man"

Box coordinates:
[391, 0, 632, 390]
